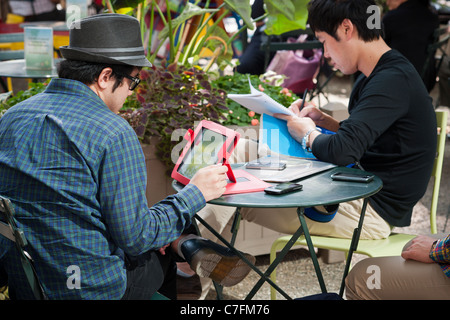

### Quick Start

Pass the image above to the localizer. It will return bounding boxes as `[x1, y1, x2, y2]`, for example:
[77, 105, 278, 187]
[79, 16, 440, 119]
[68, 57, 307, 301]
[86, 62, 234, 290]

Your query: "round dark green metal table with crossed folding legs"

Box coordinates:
[172, 165, 383, 299]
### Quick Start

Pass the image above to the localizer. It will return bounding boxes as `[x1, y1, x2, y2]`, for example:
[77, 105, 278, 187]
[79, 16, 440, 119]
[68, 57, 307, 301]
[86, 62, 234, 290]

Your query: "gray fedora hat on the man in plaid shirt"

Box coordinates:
[60, 13, 152, 67]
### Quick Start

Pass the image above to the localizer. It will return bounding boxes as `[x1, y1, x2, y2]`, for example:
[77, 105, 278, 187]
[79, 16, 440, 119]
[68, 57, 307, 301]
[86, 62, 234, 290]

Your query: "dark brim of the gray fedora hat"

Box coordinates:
[59, 46, 152, 67]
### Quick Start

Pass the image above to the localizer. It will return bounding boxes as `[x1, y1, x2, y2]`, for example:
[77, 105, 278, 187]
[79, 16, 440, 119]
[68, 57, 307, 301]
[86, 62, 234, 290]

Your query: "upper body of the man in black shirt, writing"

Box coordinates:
[274, 0, 436, 233]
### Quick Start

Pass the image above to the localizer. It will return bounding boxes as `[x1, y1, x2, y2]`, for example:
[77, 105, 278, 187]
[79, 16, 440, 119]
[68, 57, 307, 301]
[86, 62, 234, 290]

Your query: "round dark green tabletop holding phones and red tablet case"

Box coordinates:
[173, 167, 383, 208]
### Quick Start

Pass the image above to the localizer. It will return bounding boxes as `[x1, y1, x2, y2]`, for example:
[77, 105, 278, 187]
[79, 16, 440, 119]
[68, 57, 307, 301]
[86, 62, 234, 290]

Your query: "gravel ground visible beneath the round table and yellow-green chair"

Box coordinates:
[207, 74, 450, 300]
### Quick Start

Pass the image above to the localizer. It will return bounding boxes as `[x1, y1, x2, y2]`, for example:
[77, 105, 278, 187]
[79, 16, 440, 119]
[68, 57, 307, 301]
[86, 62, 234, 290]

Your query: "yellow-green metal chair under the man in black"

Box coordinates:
[270, 111, 447, 300]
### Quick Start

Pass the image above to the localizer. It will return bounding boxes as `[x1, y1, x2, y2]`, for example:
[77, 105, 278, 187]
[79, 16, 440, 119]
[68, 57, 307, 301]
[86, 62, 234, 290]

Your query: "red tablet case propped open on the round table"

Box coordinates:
[171, 120, 270, 194]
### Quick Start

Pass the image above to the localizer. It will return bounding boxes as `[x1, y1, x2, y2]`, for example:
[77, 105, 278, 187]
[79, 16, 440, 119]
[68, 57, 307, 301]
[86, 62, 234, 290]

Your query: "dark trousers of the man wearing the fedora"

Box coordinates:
[122, 251, 177, 300]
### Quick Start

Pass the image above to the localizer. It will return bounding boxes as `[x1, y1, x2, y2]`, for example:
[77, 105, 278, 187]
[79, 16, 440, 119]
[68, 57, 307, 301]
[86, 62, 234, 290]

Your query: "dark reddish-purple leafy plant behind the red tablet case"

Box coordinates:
[121, 65, 228, 172]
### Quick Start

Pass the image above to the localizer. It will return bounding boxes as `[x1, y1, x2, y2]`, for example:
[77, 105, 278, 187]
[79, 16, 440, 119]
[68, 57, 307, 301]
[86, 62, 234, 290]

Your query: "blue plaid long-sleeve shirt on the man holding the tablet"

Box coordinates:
[0, 79, 205, 299]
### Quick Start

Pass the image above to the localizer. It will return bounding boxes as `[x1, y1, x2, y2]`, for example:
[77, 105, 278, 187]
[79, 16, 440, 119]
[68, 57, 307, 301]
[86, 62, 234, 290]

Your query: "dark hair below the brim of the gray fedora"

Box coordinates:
[58, 60, 134, 91]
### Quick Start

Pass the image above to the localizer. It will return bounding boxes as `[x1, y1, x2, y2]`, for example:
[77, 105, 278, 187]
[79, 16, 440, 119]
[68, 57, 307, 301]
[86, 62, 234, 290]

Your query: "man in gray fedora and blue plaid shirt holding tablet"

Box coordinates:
[0, 14, 254, 299]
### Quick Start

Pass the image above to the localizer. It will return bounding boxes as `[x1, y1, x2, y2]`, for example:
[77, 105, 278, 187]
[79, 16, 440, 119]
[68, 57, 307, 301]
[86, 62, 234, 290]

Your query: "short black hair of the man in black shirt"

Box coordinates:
[308, 0, 382, 42]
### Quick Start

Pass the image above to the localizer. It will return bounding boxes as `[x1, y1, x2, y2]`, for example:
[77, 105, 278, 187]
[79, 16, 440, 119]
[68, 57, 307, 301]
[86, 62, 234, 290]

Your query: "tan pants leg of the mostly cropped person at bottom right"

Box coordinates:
[345, 235, 450, 300]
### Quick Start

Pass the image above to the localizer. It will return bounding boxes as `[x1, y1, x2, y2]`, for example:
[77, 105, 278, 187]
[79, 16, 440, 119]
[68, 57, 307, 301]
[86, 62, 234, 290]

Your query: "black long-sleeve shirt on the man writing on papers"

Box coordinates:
[312, 50, 437, 226]
